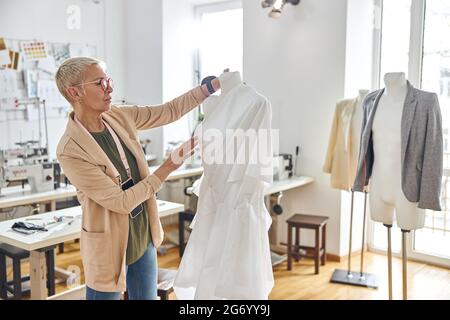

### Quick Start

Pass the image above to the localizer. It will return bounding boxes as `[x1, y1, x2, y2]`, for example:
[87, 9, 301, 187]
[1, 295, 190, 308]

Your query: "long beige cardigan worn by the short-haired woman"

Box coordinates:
[57, 87, 206, 292]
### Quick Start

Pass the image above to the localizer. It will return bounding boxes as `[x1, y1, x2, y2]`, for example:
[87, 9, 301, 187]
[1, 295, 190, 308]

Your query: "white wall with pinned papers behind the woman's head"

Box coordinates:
[0, 0, 125, 157]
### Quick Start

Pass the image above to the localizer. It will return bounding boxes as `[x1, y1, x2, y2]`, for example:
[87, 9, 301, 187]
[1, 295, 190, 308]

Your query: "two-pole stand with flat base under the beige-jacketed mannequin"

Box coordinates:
[330, 190, 378, 289]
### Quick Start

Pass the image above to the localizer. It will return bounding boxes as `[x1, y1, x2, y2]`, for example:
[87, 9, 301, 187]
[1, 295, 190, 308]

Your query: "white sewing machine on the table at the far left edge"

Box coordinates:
[0, 145, 61, 192]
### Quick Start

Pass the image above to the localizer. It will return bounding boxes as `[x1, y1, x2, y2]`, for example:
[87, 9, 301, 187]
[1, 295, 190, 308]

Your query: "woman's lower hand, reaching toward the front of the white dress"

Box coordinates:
[155, 137, 198, 182]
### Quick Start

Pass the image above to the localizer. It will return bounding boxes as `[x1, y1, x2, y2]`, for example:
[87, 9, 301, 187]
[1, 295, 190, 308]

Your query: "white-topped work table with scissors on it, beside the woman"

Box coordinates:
[0, 200, 184, 300]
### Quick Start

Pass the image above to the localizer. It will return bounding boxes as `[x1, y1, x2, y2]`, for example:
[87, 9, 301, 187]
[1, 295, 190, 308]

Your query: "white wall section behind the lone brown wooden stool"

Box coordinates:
[243, 0, 347, 255]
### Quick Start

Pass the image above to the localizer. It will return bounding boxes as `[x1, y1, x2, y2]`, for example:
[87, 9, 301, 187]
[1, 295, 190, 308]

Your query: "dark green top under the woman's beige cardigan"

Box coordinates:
[91, 129, 151, 265]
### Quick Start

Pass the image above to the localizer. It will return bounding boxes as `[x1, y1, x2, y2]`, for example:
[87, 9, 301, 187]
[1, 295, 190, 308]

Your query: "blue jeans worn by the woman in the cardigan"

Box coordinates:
[86, 243, 158, 300]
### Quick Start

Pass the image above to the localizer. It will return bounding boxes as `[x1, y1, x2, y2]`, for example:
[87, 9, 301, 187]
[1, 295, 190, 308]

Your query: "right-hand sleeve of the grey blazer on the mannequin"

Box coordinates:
[419, 95, 443, 211]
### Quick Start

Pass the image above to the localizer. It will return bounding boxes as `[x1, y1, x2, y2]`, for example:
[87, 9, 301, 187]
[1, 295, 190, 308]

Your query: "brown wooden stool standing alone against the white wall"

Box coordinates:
[286, 214, 328, 274]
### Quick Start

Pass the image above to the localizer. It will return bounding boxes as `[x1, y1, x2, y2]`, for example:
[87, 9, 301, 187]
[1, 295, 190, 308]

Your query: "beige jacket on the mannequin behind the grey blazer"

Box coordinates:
[323, 98, 359, 190]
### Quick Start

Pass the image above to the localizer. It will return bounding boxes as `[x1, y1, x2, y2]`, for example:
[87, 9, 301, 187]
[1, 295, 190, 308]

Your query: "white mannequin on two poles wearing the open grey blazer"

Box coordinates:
[370, 73, 425, 299]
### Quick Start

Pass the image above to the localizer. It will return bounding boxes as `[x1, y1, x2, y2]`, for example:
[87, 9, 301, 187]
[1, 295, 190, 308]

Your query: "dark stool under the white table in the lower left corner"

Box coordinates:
[0, 243, 55, 300]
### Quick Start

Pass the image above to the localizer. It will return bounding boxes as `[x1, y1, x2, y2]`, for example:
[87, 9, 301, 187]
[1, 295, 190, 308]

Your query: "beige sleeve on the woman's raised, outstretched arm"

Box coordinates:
[119, 86, 206, 130]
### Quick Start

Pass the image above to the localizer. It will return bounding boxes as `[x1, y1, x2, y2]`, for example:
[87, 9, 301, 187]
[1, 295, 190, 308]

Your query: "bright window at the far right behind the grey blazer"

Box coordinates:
[414, 0, 450, 259]
